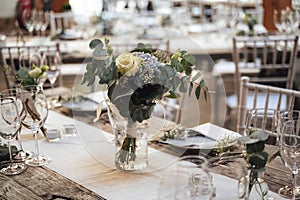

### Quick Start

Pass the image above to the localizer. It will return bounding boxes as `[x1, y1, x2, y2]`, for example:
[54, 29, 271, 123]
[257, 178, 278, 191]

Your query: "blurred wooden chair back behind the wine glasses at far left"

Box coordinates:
[0, 43, 60, 88]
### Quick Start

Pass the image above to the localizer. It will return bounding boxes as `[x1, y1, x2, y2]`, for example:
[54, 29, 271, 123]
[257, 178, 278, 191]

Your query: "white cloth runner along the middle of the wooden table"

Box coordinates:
[22, 112, 288, 200]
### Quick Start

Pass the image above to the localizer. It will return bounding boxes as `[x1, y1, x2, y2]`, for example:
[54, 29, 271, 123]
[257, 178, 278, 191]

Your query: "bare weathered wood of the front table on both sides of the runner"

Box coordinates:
[0, 108, 292, 200]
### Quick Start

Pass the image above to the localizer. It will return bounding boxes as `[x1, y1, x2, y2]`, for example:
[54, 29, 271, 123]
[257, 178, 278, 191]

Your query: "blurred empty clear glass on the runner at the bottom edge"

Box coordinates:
[175, 155, 213, 200]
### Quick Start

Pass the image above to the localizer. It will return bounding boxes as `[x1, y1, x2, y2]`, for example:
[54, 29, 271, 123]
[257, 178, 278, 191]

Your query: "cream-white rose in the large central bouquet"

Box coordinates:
[116, 53, 141, 76]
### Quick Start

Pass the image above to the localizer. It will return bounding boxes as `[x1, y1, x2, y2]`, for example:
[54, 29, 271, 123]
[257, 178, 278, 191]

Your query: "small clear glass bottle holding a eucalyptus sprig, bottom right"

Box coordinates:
[238, 170, 269, 200]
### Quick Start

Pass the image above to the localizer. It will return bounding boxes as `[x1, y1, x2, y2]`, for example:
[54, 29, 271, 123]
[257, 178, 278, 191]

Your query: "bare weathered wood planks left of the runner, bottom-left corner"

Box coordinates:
[0, 167, 105, 200]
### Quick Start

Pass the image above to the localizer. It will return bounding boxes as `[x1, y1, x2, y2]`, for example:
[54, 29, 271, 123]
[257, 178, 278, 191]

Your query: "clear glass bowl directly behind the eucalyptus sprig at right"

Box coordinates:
[245, 108, 279, 145]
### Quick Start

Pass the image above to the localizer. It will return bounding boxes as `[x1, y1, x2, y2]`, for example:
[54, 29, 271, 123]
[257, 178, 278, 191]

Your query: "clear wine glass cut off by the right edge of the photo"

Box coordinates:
[279, 118, 300, 199]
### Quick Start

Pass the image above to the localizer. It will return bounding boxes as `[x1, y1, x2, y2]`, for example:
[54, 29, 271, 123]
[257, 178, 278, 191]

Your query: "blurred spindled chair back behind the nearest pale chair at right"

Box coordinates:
[232, 35, 299, 101]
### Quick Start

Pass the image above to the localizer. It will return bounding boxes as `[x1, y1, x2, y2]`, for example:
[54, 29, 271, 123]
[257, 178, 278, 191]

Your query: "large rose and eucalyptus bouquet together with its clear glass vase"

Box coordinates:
[82, 38, 207, 170]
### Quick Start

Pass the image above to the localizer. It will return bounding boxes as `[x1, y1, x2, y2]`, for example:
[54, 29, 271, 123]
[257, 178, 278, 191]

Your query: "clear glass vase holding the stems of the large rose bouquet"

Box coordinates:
[106, 101, 148, 170]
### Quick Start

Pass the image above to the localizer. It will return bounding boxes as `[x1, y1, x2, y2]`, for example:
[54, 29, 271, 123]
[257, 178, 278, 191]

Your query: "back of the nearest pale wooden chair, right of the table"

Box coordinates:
[237, 77, 300, 135]
